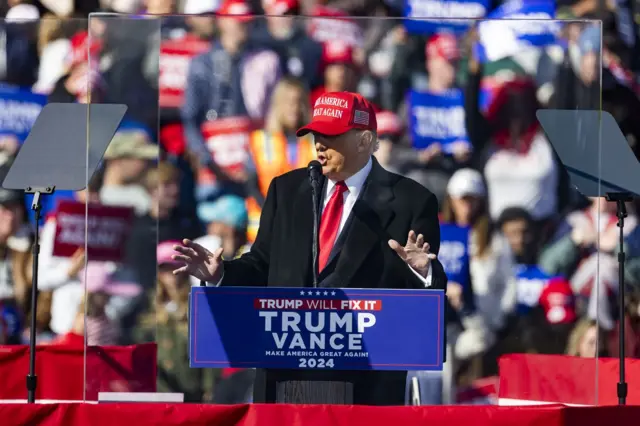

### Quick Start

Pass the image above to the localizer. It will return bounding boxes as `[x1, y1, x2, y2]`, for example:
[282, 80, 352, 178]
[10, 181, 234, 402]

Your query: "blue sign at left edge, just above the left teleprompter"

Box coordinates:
[0, 86, 47, 142]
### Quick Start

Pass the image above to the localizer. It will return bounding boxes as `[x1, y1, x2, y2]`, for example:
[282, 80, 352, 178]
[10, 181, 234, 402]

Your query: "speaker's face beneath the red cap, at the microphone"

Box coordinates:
[313, 131, 361, 181]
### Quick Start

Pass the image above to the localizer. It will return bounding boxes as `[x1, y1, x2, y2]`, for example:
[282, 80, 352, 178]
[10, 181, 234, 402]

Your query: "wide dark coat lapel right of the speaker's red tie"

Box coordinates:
[320, 158, 394, 285]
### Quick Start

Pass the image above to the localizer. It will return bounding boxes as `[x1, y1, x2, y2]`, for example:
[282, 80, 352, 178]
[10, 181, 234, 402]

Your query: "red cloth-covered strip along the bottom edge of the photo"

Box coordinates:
[0, 403, 640, 426]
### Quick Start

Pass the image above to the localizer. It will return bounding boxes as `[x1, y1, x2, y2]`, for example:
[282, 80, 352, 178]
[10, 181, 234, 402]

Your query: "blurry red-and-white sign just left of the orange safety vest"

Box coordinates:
[200, 117, 257, 183]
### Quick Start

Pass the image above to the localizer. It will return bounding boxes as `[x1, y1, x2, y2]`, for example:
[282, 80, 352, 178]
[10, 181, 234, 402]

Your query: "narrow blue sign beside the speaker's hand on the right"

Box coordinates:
[438, 224, 471, 287]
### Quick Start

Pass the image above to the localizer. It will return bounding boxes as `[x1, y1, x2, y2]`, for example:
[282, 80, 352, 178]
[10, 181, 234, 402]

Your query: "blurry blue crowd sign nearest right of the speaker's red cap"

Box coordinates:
[409, 89, 469, 154]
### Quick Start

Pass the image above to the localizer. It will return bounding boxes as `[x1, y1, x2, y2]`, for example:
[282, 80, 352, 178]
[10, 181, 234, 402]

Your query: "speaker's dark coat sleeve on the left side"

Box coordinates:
[220, 179, 277, 286]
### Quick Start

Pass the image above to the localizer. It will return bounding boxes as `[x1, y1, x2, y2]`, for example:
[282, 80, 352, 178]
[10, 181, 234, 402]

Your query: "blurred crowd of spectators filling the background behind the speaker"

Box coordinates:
[0, 0, 640, 402]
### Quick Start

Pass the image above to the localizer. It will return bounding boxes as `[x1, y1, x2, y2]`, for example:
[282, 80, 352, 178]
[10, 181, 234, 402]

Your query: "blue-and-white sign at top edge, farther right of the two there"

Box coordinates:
[475, 0, 560, 62]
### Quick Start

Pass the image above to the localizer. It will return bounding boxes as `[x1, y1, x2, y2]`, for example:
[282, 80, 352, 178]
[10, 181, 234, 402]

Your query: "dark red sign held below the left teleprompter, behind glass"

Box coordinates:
[53, 200, 133, 262]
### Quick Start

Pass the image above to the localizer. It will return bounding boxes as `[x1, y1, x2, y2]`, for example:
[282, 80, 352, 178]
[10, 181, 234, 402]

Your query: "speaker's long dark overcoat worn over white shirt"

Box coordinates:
[221, 158, 447, 405]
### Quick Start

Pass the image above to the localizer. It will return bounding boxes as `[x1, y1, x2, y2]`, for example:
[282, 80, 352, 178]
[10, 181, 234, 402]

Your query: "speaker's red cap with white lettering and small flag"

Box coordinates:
[296, 92, 378, 136]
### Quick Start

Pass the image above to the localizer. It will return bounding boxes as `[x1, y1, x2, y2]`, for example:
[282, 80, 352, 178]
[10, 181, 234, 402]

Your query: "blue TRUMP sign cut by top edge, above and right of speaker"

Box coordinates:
[404, 0, 489, 34]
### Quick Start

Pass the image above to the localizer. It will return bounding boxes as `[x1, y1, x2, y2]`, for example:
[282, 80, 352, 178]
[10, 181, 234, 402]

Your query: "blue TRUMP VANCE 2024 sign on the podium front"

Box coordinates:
[189, 287, 445, 370]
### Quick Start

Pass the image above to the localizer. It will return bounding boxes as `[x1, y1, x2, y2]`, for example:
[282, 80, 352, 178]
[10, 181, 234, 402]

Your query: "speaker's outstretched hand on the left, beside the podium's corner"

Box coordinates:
[172, 239, 224, 284]
